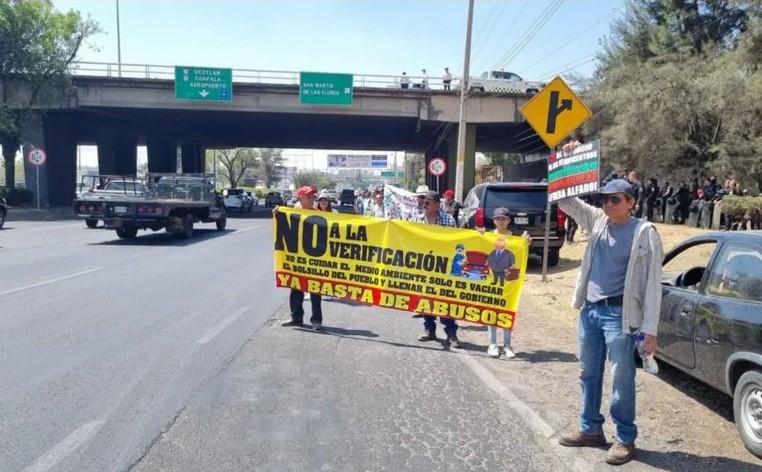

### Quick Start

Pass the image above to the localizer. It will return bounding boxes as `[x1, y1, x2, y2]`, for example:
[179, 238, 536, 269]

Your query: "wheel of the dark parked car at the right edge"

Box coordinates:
[733, 370, 762, 457]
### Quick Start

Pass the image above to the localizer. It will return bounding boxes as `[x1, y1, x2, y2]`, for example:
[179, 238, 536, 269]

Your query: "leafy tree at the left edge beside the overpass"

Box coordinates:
[0, 0, 100, 189]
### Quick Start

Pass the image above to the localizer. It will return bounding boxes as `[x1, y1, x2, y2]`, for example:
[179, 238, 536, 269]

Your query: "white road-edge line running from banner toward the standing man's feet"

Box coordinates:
[458, 356, 596, 472]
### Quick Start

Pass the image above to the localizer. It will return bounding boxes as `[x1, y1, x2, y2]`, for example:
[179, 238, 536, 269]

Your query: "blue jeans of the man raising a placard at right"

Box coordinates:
[577, 302, 638, 444]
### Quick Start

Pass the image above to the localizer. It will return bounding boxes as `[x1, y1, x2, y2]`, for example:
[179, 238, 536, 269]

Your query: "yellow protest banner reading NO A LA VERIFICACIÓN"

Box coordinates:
[273, 207, 529, 329]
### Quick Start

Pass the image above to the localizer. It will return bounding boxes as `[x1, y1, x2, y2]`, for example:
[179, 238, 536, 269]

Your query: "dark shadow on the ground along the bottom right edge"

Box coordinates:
[633, 449, 760, 472]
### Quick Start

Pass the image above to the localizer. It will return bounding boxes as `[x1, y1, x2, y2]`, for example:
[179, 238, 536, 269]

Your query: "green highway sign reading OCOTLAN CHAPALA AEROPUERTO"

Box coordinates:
[175, 66, 233, 102]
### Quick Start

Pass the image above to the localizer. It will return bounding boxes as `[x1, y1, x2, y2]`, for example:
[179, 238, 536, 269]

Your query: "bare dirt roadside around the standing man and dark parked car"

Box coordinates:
[463, 225, 762, 472]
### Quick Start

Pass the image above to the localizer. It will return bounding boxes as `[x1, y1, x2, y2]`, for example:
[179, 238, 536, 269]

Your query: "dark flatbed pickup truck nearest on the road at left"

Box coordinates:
[74, 174, 227, 239]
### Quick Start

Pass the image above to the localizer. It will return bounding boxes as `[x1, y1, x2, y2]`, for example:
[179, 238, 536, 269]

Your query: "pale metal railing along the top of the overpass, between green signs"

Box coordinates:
[70, 62, 442, 90]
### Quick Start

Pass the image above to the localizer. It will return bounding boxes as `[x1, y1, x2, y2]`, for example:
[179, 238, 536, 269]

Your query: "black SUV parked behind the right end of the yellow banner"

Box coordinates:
[459, 182, 566, 266]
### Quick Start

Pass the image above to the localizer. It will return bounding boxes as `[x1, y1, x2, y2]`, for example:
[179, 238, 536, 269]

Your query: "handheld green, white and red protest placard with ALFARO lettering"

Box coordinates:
[548, 140, 600, 202]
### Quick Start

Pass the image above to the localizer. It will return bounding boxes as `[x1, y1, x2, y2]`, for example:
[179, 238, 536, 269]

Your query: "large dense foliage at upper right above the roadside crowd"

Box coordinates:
[584, 0, 762, 190]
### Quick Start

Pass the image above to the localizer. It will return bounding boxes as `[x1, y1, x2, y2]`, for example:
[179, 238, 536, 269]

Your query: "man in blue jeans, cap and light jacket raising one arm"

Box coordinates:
[559, 179, 663, 465]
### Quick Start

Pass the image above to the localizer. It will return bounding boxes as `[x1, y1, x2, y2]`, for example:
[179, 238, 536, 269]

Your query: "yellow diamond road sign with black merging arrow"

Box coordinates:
[521, 77, 593, 148]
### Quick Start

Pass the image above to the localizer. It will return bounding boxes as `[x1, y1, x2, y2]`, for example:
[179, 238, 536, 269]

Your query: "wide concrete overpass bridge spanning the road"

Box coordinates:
[14, 63, 544, 205]
